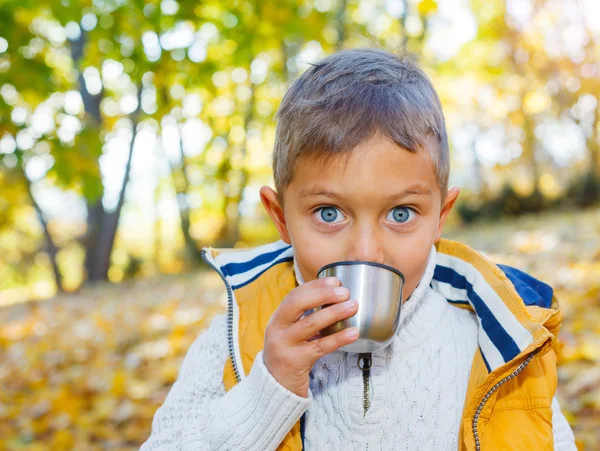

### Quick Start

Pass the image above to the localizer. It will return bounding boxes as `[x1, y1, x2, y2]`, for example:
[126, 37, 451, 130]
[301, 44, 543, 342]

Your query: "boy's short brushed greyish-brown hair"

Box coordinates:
[273, 48, 450, 204]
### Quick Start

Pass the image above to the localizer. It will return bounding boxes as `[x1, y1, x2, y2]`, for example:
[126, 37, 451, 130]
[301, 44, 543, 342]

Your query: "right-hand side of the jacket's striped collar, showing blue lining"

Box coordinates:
[431, 240, 553, 372]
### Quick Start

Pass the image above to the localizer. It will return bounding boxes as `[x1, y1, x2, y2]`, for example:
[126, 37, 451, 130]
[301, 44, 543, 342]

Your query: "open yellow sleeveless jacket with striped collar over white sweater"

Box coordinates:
[202, 239, 561, 451]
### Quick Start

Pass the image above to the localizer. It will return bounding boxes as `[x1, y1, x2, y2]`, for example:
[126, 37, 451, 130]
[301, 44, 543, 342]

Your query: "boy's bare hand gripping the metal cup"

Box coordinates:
[263, 277, 358, 397]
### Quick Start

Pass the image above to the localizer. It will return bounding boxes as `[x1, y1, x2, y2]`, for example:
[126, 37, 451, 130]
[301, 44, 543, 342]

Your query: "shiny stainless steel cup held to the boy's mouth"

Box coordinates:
[316, 261, 404, 352]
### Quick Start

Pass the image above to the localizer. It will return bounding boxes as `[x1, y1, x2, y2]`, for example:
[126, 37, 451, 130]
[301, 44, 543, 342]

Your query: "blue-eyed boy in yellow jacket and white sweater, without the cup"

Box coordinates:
[142, 49, 575, 451]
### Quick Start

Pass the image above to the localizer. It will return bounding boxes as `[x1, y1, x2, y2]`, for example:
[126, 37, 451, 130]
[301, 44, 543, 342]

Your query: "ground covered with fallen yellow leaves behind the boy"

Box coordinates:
[0, 209, 600, 451]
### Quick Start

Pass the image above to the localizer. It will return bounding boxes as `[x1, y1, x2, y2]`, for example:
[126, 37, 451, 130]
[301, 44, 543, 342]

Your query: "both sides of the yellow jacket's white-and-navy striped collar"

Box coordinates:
[206, 239, 553, 372]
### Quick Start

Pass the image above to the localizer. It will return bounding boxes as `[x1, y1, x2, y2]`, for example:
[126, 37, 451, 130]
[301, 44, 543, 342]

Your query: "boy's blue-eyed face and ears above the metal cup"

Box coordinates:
[260, 134, 460, 301]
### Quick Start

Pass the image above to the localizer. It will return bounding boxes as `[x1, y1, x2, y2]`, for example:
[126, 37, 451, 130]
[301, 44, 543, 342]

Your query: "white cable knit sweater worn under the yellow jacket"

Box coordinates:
[141, 247, 576, 451]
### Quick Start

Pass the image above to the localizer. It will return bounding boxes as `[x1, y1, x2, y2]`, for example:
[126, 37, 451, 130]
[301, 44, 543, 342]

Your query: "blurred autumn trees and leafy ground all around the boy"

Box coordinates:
[0, 0, 600, 450]
